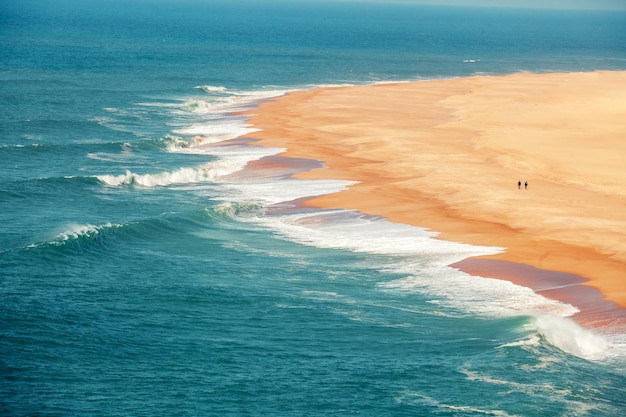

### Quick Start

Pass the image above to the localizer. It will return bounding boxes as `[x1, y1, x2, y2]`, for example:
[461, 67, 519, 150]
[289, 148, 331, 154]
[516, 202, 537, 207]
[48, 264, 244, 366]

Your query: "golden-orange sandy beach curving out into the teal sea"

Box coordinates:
[241, 71, 626, 307]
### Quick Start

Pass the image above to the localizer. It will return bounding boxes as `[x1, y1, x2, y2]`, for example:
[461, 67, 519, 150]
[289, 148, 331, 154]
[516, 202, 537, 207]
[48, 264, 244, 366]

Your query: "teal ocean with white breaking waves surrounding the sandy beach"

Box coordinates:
[0, 0, 626, 417]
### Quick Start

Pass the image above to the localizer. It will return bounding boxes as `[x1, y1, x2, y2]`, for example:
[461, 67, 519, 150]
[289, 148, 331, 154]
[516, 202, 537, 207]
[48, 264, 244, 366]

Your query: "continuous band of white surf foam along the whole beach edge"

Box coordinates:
[113, 86, 620, 357]
